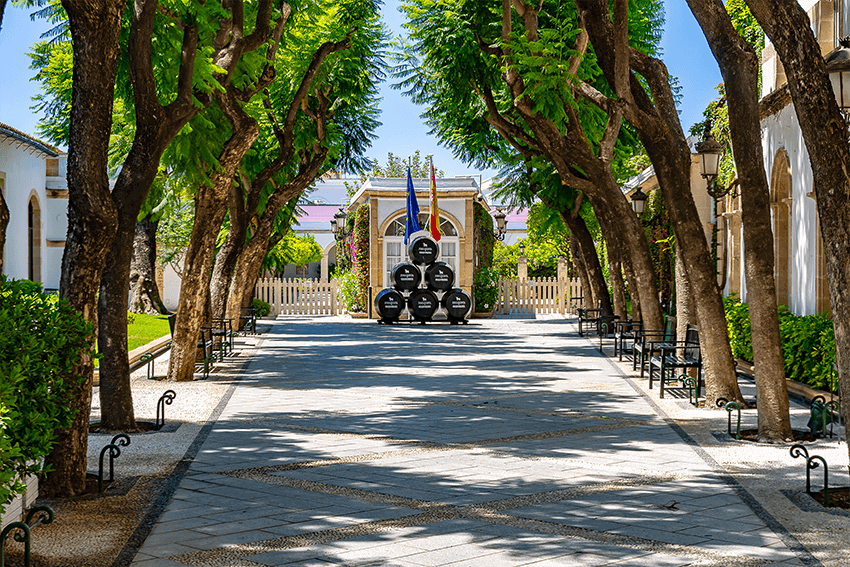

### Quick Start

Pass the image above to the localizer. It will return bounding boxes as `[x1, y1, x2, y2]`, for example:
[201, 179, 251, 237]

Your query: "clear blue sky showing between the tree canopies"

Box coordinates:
[0, 0, 721, 178]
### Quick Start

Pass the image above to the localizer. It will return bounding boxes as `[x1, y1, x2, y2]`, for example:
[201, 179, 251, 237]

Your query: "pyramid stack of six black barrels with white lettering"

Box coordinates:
[375, 234, 472, 325]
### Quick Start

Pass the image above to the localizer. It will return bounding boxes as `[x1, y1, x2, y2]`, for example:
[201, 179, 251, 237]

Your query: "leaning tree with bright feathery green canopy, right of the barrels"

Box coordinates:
[399, 0, 662, 327]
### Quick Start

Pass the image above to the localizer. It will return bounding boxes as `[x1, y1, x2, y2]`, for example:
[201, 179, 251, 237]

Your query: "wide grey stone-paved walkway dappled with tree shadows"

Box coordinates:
[133, 317, 821, 567]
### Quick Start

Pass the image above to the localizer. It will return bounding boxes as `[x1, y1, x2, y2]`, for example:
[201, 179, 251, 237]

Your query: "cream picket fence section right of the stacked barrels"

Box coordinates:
[496, 278, 581, 315]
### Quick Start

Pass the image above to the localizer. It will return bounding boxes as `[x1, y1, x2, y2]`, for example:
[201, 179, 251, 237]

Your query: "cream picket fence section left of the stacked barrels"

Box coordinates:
[254, 278, 341, 317]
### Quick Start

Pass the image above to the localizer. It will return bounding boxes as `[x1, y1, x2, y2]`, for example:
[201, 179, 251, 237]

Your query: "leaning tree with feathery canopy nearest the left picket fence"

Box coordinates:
[216, 0, 386, 328]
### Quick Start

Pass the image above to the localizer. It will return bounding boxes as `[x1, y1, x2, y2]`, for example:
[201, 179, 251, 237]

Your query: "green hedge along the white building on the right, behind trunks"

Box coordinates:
[723, 295, 838, 392]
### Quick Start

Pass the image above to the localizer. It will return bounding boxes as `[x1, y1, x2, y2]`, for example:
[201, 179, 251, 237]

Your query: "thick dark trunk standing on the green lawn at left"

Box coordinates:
[130, 215, 168, 315]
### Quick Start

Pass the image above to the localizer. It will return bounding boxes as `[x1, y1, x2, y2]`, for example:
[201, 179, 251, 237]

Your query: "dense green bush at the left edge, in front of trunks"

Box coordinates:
[0, 276, 94, 509]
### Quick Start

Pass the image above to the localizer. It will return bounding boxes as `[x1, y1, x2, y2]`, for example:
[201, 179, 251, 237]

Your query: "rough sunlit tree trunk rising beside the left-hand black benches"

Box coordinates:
[168, 93, 260, 381]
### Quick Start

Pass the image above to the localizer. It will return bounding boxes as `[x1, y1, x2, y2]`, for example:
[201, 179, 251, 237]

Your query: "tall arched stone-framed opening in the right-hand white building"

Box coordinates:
[770, 149, 793, 307]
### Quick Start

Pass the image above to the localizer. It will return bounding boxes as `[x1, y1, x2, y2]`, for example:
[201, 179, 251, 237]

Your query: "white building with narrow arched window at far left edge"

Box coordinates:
[0, 123, 68, 290]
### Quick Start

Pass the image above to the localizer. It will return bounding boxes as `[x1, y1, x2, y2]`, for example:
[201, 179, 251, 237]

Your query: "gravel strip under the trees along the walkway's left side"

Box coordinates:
[1, 328, 262, 567]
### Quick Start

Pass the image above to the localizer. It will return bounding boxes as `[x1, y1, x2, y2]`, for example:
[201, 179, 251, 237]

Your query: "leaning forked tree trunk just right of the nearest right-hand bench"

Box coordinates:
[575, 0, 743, 406]
